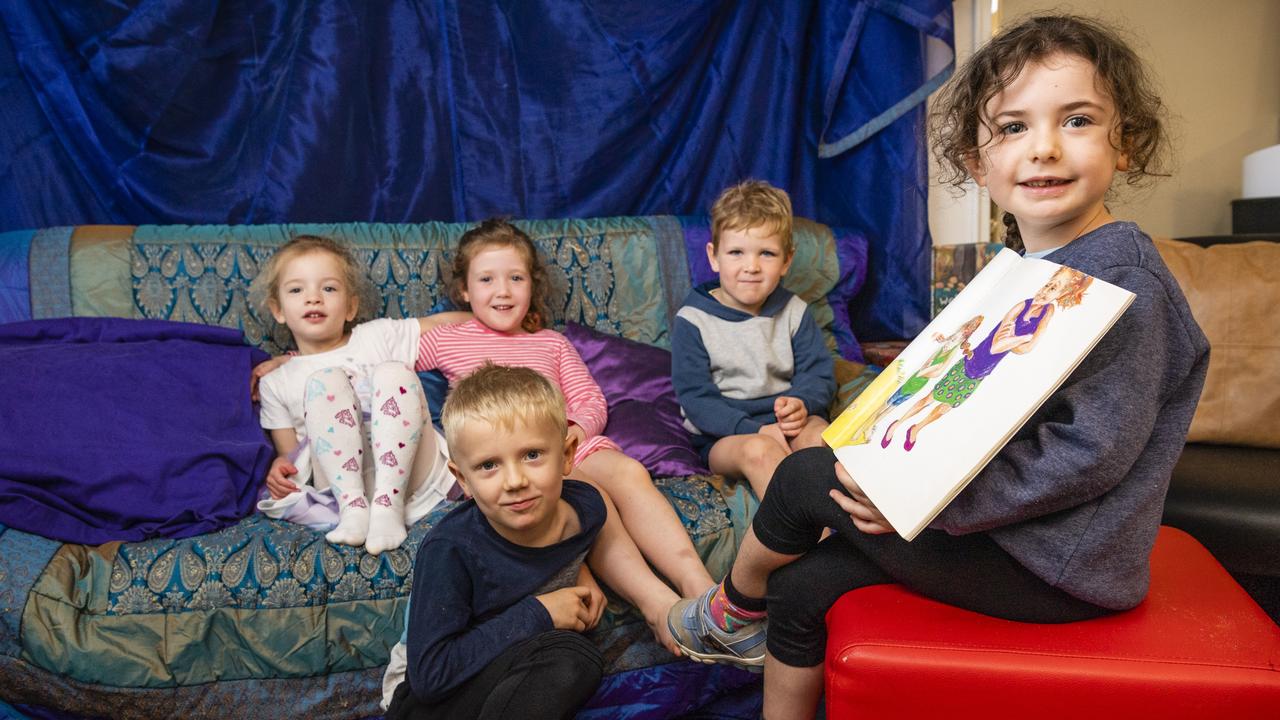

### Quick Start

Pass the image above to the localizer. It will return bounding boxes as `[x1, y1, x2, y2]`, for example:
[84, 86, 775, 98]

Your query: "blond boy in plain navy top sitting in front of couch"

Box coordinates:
[387, 364, 611, 720]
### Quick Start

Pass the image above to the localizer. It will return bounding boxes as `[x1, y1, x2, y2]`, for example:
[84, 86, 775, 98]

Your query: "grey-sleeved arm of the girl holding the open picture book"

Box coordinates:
[932, 266, 1199, 534]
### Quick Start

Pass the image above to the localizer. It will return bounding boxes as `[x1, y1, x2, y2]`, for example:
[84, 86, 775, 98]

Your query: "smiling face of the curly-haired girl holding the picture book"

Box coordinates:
[970, 54, 1128, 251]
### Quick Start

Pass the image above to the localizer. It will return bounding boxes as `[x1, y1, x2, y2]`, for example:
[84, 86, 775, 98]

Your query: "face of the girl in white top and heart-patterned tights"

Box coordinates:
[270, 252, 360, 355]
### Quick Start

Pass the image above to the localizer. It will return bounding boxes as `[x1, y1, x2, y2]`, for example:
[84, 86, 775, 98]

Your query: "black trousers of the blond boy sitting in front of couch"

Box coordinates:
[387, 630, 604, 720]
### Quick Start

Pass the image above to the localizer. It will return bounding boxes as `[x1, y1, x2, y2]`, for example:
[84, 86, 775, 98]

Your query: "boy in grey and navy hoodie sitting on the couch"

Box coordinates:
[671, 181, 836, 497]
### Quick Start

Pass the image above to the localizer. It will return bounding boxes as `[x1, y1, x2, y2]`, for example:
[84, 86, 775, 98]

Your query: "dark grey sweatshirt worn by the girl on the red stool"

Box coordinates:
[932, 222, 1208, 610]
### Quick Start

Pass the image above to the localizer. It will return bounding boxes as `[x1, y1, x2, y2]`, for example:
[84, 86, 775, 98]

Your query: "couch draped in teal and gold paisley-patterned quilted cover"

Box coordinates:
[0, 217, 873, 719]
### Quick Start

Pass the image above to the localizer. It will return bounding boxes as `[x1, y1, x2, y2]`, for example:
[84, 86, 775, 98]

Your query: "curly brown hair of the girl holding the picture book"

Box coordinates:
[929, 15, 1170, 250]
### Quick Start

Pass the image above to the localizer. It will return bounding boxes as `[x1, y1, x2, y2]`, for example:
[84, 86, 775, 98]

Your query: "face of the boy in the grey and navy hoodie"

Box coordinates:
[707, 225, 791, 315]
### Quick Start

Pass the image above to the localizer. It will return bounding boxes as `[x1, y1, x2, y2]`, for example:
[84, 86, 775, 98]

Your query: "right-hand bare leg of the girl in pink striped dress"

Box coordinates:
[570, 450, 716, 597]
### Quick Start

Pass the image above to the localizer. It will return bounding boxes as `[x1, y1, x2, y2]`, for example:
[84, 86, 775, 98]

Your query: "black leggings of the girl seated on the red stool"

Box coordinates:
[751, 447, 1111, 667]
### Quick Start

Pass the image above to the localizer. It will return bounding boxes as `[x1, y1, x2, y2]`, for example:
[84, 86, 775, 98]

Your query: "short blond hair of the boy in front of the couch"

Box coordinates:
[440, 361, 568, 448]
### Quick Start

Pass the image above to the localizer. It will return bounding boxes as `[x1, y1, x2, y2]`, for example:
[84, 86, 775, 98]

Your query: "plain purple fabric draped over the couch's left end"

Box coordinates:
[0, 318, 273, 544]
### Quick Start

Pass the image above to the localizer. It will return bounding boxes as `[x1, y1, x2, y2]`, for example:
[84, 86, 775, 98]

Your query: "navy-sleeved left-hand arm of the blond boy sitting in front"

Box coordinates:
[404, 537, 555, 702]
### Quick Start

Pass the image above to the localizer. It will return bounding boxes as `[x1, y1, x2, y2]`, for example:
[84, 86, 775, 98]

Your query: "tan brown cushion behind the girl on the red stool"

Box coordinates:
[1156, 240, 1280, 447]
